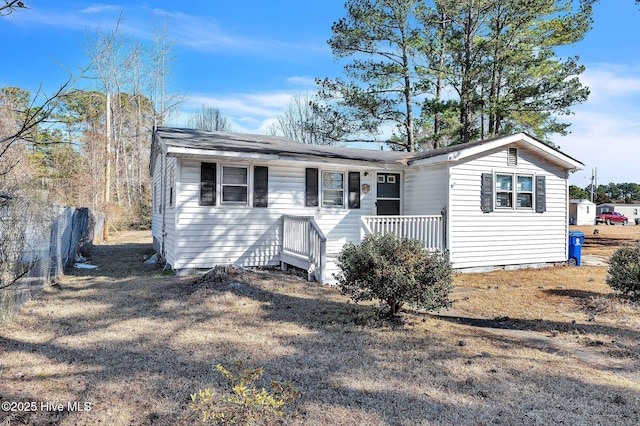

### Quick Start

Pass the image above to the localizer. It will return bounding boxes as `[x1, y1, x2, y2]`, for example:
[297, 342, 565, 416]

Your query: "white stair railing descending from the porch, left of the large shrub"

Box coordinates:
[280, 215, 327, 282]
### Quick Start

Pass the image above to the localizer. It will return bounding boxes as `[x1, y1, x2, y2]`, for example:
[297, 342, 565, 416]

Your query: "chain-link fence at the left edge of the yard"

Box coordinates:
[0, 200, 104, 318]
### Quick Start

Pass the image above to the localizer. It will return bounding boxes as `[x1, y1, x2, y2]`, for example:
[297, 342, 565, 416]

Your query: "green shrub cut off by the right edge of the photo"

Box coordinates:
[607, 242, 640, 299]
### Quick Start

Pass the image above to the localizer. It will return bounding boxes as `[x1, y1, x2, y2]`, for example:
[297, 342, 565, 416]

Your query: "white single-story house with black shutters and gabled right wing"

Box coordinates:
[150, 127, 583, 282]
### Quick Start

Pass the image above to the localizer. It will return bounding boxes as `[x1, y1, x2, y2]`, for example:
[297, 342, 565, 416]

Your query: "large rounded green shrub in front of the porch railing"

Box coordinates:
[335, 234, 452, 315]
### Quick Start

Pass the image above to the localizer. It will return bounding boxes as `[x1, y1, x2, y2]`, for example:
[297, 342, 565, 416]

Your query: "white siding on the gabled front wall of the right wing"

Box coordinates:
[448, 144, 567, 268]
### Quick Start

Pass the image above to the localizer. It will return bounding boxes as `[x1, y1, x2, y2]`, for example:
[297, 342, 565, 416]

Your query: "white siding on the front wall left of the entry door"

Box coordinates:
[172, 160, 374, 278]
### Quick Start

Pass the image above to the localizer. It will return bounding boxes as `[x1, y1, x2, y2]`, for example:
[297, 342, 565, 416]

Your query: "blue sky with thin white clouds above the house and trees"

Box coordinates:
[0, 0, 640, 187]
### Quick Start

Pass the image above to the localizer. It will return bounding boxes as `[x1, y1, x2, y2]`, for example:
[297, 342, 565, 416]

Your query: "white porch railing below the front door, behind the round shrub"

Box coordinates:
[360, 215, 445, 251]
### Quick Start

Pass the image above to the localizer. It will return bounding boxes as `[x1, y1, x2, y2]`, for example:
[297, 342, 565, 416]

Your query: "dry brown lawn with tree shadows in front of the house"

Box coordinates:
[0, 226, 640, 425]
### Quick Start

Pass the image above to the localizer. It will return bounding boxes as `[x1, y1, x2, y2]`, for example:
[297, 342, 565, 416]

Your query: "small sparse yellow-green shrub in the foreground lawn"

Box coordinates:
[191, 361, 302, 425]
